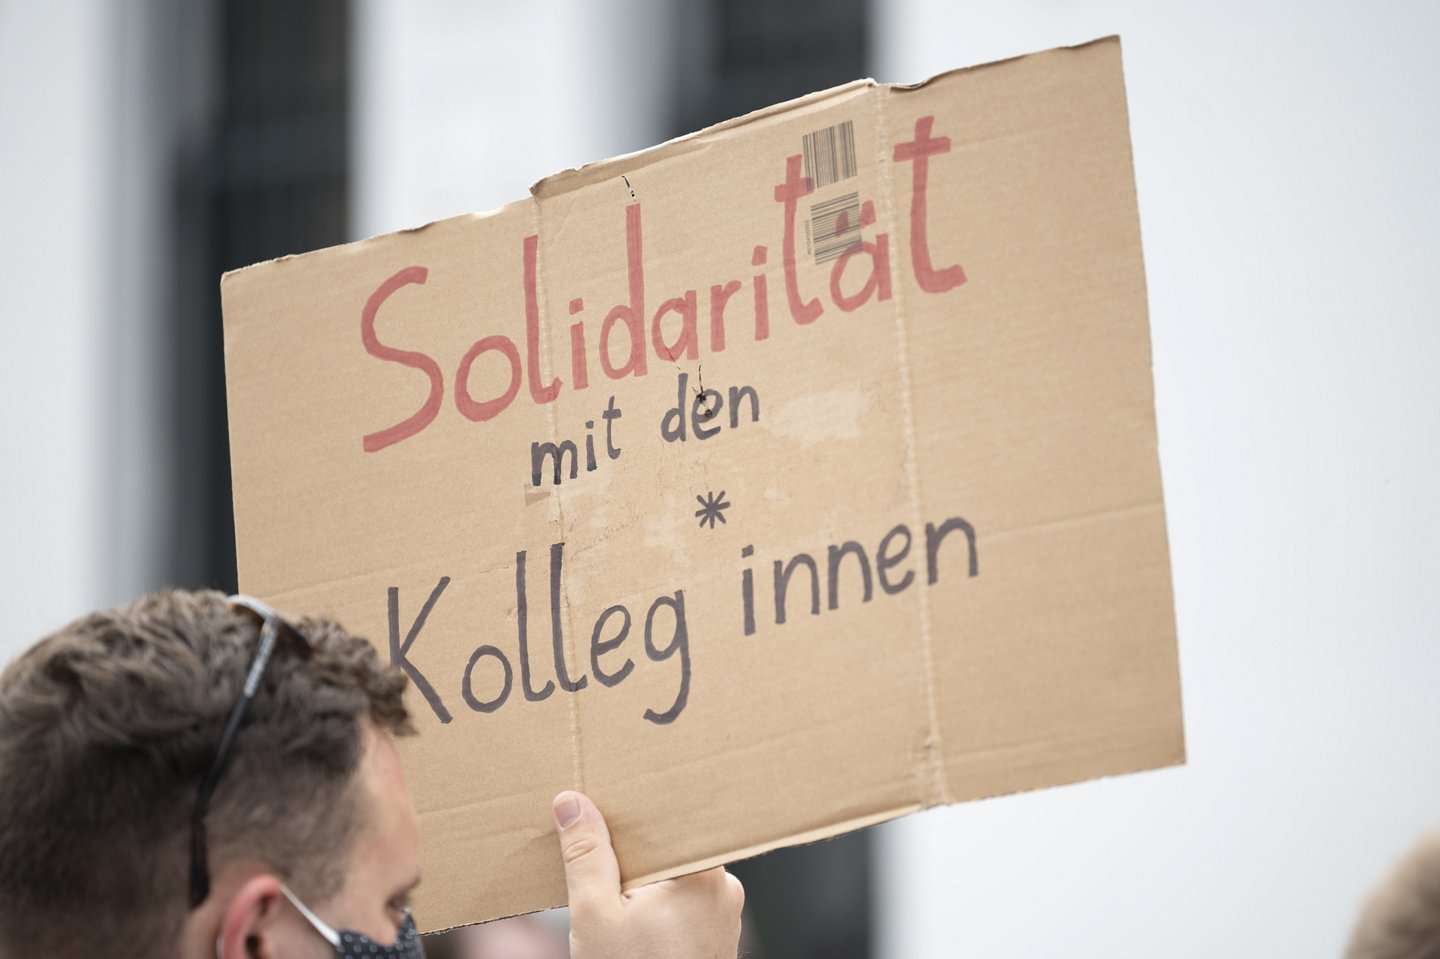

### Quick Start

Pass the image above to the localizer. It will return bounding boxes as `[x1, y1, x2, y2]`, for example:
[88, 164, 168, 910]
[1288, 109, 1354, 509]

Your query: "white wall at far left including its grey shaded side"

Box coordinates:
[0, 0, 173, 668]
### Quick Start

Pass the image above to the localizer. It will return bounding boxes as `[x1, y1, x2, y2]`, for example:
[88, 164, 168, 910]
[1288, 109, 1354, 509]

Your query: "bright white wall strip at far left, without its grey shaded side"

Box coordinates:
[0, 0, 114, 664]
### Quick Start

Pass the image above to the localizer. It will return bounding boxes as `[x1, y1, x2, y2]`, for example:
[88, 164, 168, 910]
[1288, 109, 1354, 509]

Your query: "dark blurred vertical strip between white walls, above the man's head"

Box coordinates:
[171, 0, 350, 590]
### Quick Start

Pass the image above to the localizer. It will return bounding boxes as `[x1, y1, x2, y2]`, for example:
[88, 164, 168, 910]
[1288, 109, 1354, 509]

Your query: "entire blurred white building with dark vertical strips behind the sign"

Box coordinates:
[0, 0, 1440, 959]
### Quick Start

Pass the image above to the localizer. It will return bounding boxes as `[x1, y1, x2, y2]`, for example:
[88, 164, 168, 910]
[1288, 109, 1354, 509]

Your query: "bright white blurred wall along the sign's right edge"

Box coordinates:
[873, 0, 1440, 959]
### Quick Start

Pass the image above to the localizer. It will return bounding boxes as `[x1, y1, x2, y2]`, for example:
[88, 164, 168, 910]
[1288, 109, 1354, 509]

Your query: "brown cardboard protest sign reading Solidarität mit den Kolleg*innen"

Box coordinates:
[223, 37, 1184, 929]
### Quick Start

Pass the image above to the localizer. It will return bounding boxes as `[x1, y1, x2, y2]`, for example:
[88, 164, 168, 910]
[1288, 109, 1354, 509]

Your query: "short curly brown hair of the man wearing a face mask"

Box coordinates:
[0, 590, 413, 956]
